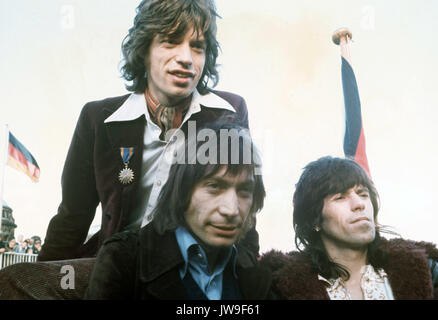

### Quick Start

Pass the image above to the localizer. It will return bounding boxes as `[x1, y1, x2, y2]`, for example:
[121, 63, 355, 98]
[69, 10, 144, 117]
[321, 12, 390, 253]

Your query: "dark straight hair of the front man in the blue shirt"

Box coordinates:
[151, 122, 266, 234]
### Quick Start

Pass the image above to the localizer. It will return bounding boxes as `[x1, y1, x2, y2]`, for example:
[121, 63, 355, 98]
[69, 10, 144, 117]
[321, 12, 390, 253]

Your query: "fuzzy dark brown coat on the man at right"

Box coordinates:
[261, 239, 438, 300]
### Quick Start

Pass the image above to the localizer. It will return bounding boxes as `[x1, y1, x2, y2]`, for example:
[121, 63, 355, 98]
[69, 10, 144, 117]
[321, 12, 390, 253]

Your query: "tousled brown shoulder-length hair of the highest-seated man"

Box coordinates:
[120, 0, 219, 94]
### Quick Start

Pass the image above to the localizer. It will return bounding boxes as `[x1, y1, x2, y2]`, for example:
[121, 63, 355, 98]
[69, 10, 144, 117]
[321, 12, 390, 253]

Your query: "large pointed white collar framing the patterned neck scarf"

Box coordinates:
[104, 89, 236, 123]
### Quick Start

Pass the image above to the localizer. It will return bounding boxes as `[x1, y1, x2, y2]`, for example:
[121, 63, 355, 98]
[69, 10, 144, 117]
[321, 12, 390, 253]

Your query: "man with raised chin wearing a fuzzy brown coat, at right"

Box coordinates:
[262, 157, 438, 300]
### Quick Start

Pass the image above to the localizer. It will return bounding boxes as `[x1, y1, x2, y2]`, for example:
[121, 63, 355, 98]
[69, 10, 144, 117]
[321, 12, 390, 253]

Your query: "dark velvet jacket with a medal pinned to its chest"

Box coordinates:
[38, 91, 252, 261]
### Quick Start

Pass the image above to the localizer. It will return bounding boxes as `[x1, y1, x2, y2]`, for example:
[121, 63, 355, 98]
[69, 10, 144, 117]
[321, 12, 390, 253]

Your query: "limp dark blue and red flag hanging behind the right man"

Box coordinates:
[342, 46, 371, 177]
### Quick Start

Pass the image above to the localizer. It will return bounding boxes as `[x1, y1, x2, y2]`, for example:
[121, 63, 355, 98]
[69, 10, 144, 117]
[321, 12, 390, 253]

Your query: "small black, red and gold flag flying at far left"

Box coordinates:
[8, 132, 40, 182]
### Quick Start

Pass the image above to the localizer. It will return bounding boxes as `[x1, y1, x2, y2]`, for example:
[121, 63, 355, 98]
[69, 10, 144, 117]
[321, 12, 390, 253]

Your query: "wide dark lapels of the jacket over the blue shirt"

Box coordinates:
[139, 224, 271, 300]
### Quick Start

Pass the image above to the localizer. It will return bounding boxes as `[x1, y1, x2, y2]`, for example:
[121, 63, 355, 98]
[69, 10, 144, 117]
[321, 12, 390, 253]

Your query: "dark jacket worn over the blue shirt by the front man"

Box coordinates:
[85, 224, 271, 300]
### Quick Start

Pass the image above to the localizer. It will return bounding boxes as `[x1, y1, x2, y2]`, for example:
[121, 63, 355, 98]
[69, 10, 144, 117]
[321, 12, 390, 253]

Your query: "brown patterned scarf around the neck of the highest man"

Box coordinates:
[144, 88, 191, 138]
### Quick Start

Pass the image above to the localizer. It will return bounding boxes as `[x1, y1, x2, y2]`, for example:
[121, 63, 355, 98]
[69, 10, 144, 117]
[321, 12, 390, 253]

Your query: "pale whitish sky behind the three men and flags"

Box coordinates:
[0, 0, 438, 252]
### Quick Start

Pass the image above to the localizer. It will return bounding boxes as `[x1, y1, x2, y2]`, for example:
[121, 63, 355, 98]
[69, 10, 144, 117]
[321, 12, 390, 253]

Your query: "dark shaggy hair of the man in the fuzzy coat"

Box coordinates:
[293, 156, 385, 279]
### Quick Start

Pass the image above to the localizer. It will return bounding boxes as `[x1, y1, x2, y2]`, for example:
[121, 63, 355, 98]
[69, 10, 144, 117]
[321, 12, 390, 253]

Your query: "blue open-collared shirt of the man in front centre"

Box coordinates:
[175, 227, 237, 300]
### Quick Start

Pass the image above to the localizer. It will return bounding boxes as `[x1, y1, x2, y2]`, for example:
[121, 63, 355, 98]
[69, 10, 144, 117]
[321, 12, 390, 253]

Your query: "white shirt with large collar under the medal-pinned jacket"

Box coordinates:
[104, 89, 235, 230]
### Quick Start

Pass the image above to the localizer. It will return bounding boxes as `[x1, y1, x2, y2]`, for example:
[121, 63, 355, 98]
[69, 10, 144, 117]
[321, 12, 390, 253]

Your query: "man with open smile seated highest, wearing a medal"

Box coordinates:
[38, 0, 258, 261]
